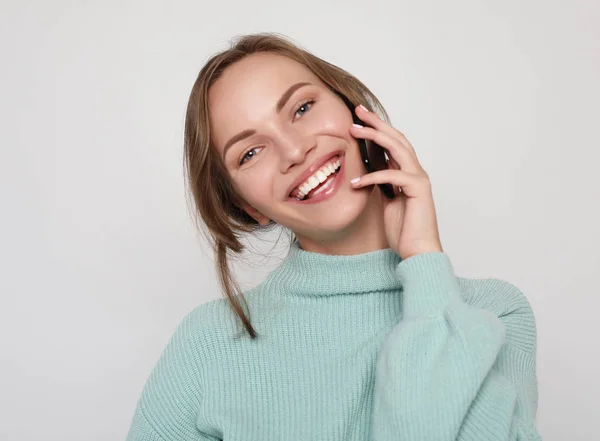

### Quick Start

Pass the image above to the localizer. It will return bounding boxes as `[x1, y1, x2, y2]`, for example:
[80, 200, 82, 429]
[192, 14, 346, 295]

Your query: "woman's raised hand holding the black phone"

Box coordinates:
[350, 106, 443, 260]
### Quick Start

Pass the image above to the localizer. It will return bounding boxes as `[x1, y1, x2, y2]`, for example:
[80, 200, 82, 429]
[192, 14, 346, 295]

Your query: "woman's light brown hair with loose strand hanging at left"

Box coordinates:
[184, 33, 389, 339]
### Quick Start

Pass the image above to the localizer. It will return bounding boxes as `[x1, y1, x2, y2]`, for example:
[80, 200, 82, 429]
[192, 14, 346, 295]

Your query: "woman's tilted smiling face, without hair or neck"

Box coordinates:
[209, 53, 378, 243]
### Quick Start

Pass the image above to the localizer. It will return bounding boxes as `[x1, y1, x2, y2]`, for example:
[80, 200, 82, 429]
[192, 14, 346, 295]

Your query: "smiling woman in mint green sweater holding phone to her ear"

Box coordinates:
[128, 34, 539, 441]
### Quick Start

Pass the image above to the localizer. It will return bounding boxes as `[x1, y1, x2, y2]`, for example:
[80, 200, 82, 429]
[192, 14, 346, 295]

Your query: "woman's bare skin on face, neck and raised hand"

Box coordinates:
[209, 53, 443, 259]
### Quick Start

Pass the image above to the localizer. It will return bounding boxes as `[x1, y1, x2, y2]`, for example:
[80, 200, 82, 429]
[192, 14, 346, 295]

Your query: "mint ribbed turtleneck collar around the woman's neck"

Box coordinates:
[264, 242, 402, 296]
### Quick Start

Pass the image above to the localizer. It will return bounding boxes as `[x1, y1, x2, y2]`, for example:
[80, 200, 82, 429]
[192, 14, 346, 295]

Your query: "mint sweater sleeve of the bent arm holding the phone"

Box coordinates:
[372, 252, 541, 441]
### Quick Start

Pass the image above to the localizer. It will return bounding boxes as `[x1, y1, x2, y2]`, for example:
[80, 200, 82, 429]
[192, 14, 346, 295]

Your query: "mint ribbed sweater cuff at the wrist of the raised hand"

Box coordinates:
[396, 252, 463, 317]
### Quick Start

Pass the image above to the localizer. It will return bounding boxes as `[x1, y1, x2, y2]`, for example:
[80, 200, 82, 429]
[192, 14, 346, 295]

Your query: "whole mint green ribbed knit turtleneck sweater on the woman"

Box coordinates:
[127, 245, 540, 441]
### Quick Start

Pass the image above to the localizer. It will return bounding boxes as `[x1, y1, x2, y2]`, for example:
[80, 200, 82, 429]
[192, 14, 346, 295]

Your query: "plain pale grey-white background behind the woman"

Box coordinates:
[0, 0, 600, 441]
